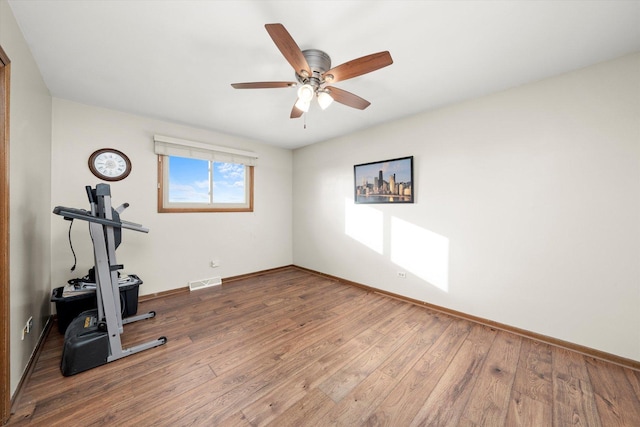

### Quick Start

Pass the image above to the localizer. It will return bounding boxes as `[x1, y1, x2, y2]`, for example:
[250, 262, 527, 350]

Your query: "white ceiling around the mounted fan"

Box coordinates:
[7, 0, 640, 148]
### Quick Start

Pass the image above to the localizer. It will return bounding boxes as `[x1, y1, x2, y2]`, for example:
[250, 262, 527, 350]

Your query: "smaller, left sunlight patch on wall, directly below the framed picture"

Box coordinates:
[344, 199, 384, 254]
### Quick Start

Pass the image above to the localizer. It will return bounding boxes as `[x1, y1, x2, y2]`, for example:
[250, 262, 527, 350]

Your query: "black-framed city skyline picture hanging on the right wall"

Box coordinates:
[353, 156, 414, 203]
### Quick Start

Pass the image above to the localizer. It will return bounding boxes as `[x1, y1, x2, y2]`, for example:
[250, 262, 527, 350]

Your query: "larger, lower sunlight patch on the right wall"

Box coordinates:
[391, 217, 449, 292]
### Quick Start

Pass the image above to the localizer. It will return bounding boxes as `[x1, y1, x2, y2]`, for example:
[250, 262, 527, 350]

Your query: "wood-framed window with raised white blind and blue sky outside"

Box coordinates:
[154, 135, 256, 212]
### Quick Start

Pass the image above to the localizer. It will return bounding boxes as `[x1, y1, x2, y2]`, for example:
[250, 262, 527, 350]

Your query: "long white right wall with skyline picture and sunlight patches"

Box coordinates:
[293, 54, 640, 360]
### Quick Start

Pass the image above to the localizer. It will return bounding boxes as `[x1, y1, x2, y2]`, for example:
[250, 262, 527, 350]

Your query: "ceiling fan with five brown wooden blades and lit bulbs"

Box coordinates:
[231, 24, 393, 119]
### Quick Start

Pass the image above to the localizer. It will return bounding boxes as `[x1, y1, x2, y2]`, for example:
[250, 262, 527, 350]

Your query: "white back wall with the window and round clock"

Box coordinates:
[51, 98, 292, 295]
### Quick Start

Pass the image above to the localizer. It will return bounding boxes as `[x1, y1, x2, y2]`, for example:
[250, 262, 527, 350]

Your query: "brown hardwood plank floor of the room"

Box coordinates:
[9, 267, 640, 426]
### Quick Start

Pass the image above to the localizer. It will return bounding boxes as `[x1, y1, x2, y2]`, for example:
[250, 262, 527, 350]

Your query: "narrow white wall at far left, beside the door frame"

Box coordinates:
[0, 0, 51, 394]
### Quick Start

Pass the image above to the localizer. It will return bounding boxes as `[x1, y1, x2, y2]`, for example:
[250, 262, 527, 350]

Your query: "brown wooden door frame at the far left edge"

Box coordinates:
[0, 46, 11, 424]
